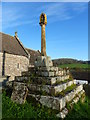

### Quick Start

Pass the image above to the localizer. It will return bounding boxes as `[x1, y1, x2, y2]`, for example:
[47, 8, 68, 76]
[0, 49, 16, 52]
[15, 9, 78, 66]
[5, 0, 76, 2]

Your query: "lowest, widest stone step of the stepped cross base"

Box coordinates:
[29, 85, 84, 111]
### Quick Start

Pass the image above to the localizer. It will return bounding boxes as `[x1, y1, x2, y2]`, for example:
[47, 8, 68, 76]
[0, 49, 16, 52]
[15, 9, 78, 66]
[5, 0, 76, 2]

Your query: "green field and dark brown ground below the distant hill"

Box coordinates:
[58, 63, 90, 83]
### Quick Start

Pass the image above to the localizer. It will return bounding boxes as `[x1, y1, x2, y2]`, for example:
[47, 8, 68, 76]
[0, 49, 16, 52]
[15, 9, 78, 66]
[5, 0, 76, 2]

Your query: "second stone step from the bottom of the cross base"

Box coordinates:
[27, 80, 76, 95]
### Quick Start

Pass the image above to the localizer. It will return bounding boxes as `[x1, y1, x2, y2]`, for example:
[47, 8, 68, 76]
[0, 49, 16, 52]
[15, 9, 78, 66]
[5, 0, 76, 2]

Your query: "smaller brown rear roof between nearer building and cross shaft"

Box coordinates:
[26, 48, 41, 65]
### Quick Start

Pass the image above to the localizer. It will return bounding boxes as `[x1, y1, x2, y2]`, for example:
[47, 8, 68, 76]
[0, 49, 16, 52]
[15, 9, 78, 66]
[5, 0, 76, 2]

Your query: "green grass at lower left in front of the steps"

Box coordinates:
[2, 92, 55, 120]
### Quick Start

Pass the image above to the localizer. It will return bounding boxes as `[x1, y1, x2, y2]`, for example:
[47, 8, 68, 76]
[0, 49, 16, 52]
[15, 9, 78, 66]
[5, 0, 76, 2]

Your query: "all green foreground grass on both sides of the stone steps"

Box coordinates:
[2, 92, 90, 120]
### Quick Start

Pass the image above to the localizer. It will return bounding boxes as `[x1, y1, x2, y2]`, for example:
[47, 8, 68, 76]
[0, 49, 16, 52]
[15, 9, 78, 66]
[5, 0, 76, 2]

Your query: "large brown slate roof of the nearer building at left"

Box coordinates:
[0, 32, 28, 57]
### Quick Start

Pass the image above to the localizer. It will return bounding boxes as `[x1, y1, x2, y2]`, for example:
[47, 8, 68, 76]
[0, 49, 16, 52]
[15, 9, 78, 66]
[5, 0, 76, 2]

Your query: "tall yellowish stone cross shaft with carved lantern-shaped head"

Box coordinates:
[39, 13, 47, 56]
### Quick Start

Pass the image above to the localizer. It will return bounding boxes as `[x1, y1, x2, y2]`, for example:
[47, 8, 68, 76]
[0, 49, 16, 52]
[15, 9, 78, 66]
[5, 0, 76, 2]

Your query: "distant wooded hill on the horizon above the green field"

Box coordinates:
[52, 58, 90, 66]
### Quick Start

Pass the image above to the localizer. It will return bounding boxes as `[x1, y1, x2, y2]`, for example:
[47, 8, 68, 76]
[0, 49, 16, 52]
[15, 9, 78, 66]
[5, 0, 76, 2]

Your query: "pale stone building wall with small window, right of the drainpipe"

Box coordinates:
[0, 53, 29, 80]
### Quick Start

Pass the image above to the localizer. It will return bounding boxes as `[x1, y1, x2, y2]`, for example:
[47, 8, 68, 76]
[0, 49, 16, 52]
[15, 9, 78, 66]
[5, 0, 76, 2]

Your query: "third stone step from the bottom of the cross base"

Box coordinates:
[15, 75, 69, 85]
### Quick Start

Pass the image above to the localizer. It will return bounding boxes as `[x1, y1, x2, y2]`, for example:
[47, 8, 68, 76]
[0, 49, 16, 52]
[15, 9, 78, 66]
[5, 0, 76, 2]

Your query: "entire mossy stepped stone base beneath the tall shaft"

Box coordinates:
[11, 56, 84, 118]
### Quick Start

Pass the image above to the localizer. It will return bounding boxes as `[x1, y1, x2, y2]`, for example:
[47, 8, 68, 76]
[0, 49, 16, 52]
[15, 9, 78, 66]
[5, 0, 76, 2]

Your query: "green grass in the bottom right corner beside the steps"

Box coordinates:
[65, 97, 90, 120]
